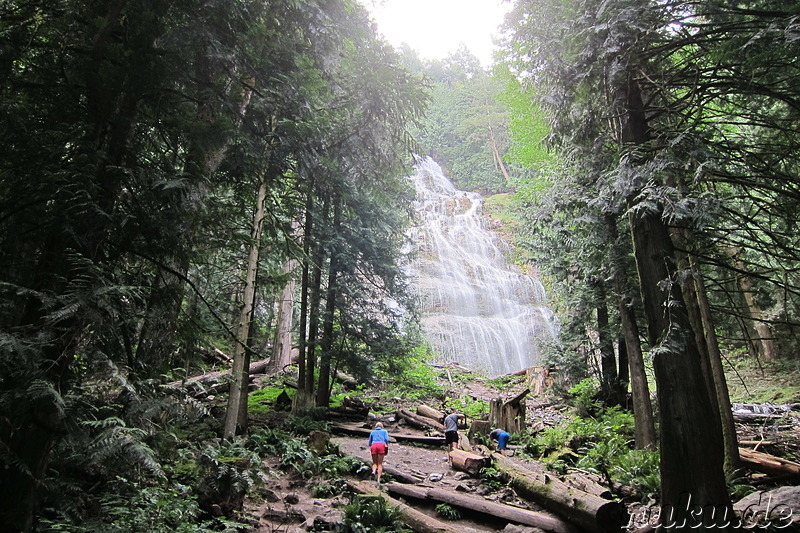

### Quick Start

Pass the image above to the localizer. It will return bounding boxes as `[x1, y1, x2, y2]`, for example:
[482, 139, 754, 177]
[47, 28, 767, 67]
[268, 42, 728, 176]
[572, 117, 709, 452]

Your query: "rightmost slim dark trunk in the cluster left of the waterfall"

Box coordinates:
[317, 198, 342, 407]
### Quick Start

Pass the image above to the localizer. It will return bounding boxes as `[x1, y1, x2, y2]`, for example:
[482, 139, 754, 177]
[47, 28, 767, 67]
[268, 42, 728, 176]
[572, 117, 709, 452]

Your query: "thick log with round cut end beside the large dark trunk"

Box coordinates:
[493, 455, 628, 533]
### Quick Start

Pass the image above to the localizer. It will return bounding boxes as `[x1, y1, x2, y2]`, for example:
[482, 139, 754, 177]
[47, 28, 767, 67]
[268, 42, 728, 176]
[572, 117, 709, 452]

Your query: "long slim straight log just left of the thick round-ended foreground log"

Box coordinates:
[386, 483, 580, 533]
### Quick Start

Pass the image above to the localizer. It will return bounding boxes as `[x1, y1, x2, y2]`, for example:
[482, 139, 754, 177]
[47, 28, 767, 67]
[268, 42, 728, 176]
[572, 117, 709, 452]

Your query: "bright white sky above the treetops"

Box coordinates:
[362, 0, 511, 67]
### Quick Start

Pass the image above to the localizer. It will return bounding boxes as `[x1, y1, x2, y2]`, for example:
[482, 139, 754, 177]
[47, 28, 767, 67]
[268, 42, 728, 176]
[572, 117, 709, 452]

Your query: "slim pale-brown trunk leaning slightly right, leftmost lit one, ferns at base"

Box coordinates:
[223, 171, 267, 440]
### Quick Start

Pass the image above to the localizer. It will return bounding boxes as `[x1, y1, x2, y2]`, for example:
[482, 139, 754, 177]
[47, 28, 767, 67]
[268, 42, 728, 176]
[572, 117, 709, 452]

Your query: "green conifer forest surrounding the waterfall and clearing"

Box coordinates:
[0, 0, 800, 533]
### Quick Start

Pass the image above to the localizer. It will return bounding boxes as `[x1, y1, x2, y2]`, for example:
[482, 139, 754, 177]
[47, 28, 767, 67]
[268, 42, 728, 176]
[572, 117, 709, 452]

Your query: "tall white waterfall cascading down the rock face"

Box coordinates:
[410, 158, 556, 376]
